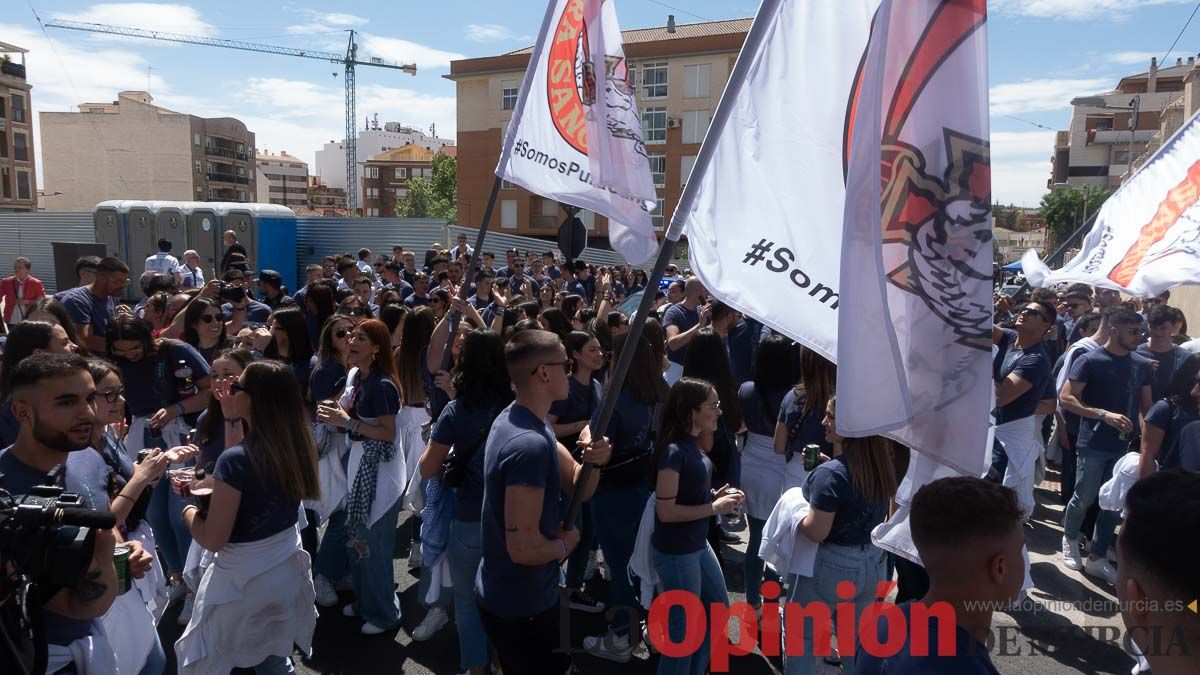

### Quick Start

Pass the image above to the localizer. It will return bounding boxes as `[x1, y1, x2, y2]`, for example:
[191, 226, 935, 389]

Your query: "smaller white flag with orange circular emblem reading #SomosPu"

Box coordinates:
[496, 0, 658, 264]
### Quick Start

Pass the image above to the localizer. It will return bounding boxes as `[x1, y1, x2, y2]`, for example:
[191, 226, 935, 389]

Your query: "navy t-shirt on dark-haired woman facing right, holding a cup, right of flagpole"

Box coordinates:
[650, 438, 713, 555]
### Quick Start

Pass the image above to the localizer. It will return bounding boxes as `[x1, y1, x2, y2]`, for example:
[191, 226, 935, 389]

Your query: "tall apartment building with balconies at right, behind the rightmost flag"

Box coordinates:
[1046, 56, 1196, 189]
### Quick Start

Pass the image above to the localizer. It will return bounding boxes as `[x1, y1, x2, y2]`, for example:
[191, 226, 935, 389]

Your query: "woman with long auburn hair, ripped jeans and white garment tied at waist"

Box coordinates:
[317, 318, 408, 635]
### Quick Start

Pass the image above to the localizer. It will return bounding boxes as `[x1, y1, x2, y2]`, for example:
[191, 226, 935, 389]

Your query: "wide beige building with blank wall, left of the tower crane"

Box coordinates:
[41, 91, 257, 211]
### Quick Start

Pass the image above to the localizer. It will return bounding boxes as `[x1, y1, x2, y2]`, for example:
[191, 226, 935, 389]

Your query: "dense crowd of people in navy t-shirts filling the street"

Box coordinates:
[0, 232, 1200, 675]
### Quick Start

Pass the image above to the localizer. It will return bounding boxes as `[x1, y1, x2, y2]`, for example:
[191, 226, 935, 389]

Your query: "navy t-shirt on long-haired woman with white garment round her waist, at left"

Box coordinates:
[212, 444, 300, 544]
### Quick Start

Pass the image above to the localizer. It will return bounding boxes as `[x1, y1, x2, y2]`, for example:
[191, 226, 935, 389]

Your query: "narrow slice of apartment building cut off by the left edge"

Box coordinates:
[0, 42, 37, 211]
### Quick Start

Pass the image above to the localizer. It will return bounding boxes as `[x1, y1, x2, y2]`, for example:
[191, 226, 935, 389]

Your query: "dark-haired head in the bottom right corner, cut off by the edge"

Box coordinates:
[1116, 468, 1200, 675]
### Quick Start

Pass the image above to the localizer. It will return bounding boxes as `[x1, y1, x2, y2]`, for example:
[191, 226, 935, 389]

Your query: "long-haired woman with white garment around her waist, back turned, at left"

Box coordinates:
[175, 362, 320, 675]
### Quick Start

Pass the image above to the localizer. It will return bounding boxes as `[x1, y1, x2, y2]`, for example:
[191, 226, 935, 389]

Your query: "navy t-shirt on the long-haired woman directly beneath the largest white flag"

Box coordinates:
[804, 456, 888, 546]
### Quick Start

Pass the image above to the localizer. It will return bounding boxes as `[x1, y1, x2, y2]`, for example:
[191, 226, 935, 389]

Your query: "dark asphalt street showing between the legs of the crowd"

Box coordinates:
[160, 471, 1133, 675]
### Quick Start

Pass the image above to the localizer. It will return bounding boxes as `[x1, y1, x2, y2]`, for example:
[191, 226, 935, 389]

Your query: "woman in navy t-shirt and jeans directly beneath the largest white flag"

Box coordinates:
[787, 399, 896, 675]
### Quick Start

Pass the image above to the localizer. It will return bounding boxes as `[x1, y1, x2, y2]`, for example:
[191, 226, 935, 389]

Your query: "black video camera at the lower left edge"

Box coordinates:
[0, 467, 116, 674]
